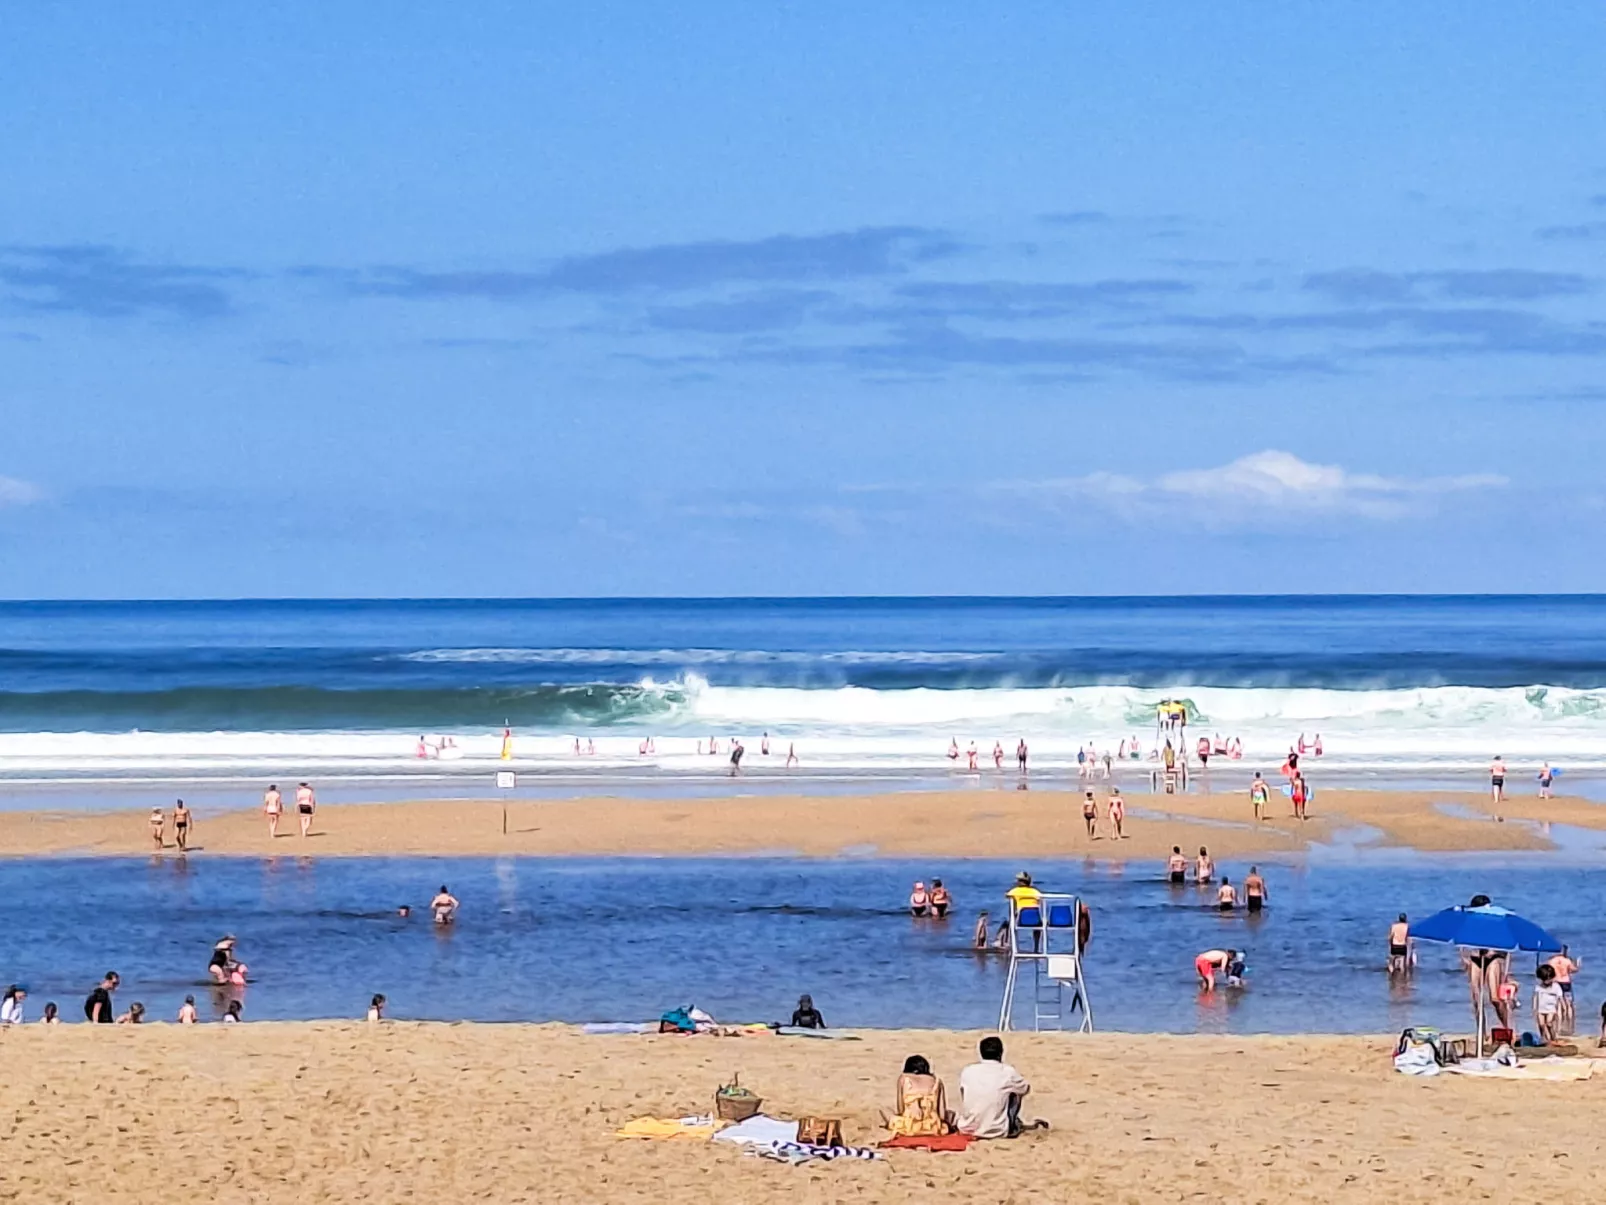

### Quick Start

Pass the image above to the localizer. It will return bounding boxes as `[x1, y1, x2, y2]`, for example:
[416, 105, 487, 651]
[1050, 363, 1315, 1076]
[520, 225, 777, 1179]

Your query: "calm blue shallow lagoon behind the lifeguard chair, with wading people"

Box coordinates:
[0, 858, 1606, 1033]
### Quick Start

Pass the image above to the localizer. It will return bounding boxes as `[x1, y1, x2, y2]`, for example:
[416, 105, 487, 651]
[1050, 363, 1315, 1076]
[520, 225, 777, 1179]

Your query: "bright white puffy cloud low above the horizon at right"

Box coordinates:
[1002, 450, 1506, 519]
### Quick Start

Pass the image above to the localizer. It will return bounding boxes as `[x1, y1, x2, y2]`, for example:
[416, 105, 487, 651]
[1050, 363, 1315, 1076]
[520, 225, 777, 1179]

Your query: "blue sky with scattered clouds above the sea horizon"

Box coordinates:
[0, 0, 1606, 598]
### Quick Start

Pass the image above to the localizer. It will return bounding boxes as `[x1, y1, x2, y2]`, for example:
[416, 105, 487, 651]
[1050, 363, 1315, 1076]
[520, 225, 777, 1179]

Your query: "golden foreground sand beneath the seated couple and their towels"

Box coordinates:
[0, 1022, 1606, 1205]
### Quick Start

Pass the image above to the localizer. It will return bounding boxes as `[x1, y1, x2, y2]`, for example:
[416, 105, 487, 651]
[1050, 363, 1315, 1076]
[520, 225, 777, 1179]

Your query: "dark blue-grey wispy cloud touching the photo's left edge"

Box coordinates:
[0, 244, 251, 320]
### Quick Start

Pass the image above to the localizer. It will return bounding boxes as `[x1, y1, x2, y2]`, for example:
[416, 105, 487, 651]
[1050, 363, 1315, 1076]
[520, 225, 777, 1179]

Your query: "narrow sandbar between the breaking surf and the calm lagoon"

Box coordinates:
[0, 786, 1606, 860]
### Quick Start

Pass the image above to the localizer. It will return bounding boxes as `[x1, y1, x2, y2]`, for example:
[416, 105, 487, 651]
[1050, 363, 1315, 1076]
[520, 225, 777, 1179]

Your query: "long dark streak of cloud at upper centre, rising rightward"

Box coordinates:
[326, 227, 959, 302]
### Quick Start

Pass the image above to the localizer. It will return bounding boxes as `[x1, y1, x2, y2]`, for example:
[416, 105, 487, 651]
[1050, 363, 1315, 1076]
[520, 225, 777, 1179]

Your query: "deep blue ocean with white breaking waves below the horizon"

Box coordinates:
[0, 596, 1606, 797]
